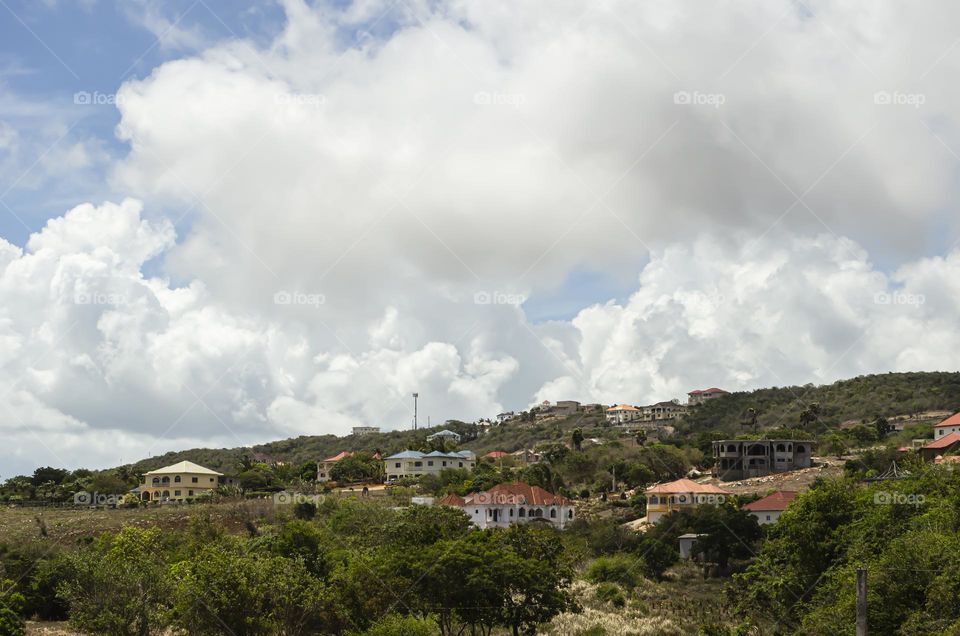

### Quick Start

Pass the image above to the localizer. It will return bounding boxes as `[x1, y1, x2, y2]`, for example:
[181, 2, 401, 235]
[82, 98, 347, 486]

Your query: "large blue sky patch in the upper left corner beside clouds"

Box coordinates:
[0, 0, 283, 245]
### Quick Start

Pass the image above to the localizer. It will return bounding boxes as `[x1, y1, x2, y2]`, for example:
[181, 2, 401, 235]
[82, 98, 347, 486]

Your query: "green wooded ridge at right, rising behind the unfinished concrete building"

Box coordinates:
[684, 372, 960, 430]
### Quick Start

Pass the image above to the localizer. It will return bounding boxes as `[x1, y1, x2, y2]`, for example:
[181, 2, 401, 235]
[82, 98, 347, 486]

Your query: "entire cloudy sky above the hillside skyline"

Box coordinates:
[0, 0, 960, 478]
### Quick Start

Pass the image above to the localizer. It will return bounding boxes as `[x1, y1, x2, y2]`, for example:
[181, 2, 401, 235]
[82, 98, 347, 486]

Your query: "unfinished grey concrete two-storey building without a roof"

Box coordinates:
[713, 439, 814, 481]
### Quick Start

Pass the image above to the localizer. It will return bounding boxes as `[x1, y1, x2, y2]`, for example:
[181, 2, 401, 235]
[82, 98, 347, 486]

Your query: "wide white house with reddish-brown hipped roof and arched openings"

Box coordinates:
[438, 482, 576, 530]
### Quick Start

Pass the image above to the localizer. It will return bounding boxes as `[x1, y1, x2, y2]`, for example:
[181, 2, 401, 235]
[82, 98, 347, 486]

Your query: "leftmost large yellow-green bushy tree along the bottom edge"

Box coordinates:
[60, 526, 170, 636]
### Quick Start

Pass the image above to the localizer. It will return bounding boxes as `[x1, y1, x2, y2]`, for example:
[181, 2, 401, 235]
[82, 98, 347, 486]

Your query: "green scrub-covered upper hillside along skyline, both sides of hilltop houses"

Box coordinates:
[124, 372, 960, 472]
